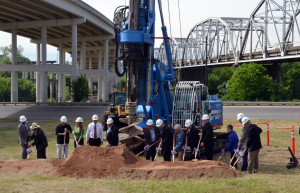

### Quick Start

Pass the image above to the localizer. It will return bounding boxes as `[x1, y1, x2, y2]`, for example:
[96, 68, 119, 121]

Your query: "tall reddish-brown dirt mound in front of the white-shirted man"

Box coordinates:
[57, 146, 140, 178]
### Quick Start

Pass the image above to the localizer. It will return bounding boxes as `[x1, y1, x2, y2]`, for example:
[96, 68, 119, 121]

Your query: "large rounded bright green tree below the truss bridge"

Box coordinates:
[228, 63, 287, 101]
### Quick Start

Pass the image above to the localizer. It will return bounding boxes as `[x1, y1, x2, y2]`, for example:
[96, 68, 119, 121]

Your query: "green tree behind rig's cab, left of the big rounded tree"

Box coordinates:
[208, 67, 233, 97]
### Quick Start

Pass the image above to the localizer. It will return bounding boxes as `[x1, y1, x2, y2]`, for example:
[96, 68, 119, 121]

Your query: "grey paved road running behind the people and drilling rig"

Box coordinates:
[0, 106, 300, 127]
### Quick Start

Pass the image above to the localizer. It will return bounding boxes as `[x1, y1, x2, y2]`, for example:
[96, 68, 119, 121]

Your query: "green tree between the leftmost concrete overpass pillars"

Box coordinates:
[18, 79, 36, 102]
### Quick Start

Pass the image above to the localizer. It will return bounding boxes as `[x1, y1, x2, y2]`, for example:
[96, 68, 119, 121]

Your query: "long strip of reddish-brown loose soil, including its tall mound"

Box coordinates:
[0, 145, 240, 180]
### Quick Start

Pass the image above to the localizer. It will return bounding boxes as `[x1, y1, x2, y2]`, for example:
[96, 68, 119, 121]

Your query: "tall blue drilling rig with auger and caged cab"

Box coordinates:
[114, 0, 223, 154]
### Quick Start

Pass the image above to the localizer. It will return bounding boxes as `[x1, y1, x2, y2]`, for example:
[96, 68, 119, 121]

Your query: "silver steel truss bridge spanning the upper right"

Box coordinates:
[157, 0, 300, 70]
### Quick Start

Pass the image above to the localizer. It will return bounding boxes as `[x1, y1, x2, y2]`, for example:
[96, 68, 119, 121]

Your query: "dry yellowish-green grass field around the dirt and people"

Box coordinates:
[0, 119, 300, 193]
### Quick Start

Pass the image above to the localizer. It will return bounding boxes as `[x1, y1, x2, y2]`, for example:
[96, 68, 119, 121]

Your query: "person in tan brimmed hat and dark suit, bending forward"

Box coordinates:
[29, 123, 48, 159]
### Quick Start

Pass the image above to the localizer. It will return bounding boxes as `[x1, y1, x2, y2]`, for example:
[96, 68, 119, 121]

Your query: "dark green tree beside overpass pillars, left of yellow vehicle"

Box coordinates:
[72, 75, 90, 102]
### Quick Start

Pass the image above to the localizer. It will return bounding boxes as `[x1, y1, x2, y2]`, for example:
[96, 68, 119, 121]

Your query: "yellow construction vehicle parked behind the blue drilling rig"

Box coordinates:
[102, 91, 127, 131]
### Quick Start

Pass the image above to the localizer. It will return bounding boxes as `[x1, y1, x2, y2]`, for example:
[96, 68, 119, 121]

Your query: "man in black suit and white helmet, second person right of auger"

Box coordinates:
[156, 119, 173, 161]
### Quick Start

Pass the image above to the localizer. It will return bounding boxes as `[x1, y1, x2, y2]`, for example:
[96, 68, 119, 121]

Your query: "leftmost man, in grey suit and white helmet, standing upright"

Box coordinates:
[18, 115, 31, 159]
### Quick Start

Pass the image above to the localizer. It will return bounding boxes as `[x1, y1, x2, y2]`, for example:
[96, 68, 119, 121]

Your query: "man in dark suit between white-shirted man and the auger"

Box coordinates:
[106, 118, 119, 146]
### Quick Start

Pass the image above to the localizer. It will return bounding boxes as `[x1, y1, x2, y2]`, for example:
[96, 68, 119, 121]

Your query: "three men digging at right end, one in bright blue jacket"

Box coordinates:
[224, 113, 262, 174]
